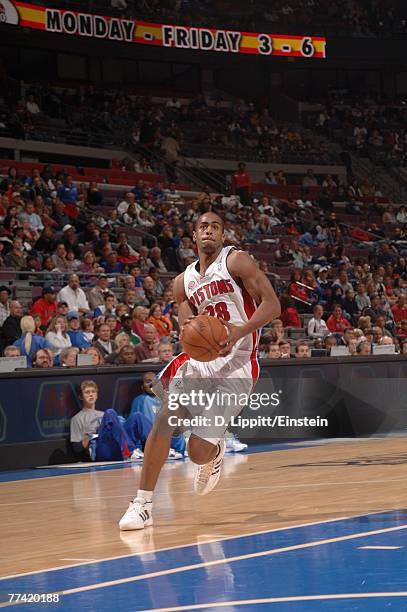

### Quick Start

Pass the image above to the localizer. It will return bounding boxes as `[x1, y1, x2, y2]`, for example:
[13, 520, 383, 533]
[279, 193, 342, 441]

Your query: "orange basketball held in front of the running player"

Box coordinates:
[182, 314, 228, 361]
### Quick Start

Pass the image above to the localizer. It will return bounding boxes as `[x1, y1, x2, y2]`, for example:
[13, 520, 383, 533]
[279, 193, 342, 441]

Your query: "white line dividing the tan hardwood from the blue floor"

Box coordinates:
[0, 510, 388, 582]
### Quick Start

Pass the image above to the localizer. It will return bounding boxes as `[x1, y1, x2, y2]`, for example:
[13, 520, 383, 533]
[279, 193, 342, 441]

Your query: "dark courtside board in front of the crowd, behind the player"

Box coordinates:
[0, 357, 407, 470]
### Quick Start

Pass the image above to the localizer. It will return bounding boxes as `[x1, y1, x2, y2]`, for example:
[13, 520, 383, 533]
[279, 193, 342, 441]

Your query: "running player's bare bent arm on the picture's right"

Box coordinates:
[219, 251, 281, 356]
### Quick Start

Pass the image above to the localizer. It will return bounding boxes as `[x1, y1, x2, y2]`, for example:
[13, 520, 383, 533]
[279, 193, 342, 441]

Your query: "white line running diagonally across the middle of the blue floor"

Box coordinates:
[0, 525, 407, 609]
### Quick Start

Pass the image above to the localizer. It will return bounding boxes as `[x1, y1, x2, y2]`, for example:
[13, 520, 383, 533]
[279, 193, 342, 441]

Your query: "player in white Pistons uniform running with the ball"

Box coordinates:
[119, 212, 280, 530]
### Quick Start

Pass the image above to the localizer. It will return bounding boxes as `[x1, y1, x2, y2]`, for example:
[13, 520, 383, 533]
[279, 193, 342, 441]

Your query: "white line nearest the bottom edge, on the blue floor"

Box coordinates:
[143, 591, 407, 612]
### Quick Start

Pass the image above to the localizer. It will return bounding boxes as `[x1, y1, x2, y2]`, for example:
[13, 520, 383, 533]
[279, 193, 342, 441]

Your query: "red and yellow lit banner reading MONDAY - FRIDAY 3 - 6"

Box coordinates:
[0, 0, 326, 59]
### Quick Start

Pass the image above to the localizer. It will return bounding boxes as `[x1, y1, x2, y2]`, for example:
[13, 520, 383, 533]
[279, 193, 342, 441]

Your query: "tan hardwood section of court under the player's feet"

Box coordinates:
[0, 438, 407, 576]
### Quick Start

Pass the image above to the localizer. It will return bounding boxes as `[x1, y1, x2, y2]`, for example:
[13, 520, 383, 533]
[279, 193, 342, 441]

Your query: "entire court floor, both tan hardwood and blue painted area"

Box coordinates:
[0, 437, 407, 612]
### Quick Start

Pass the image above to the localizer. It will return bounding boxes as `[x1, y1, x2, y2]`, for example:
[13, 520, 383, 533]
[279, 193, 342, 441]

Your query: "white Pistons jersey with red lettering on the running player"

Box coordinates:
[184, 246, 258, 359]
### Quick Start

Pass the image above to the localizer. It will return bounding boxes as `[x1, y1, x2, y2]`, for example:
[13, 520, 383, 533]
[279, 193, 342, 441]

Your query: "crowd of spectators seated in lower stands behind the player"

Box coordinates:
[0, 164, 407, 367]
